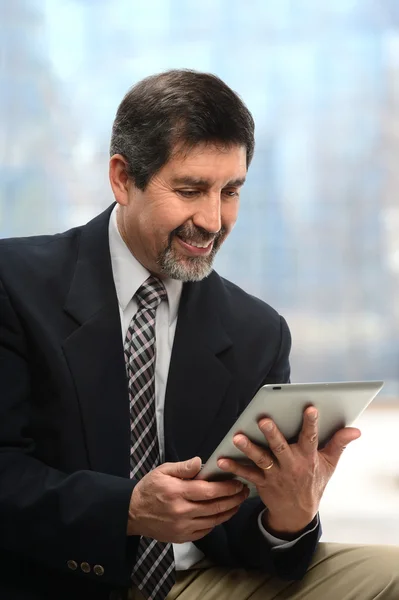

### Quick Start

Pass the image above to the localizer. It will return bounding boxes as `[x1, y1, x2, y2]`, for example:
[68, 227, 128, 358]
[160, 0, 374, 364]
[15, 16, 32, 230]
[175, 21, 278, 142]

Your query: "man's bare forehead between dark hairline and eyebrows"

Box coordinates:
[161, 144, 247, 184]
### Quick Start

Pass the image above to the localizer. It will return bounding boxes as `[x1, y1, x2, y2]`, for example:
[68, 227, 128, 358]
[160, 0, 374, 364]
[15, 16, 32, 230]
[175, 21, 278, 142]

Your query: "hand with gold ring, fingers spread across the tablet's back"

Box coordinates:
[218, 407, 360, 539]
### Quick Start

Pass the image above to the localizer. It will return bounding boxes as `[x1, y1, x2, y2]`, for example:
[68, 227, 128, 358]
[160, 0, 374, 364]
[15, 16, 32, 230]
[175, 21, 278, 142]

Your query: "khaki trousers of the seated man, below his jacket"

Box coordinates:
[132, 543, 399, 600]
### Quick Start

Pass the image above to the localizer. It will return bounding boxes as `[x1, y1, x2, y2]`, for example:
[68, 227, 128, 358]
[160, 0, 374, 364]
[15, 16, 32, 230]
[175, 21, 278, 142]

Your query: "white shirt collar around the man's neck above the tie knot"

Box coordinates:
[108, 205, 183, 325]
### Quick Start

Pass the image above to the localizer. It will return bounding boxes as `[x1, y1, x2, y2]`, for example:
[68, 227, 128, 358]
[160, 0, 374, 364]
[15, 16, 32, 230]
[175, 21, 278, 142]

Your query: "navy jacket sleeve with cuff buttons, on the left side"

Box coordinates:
[0, 282, 138, 585]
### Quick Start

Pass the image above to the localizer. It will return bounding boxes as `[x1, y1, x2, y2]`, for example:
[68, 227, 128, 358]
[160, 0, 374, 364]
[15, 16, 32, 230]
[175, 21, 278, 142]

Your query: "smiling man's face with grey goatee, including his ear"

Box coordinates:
[110, 144, 246, 281]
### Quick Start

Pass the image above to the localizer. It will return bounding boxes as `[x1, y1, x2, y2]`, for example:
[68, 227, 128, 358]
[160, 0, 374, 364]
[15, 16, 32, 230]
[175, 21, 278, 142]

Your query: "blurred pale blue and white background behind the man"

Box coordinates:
[0, 0, 399, 543]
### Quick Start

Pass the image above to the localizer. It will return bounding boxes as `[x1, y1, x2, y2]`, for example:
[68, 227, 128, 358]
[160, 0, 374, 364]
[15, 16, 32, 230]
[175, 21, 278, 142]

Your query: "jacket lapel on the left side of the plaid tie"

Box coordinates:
[63, 209, 130, 477]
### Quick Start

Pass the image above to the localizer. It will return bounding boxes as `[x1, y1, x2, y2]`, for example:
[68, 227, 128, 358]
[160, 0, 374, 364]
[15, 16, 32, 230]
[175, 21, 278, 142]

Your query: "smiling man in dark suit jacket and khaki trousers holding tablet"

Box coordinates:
[0, 71, 399, 600]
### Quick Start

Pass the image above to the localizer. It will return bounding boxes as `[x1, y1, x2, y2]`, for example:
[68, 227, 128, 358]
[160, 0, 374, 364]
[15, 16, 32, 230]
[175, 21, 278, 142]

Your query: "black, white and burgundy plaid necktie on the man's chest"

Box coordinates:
[124, 276, 175, 600]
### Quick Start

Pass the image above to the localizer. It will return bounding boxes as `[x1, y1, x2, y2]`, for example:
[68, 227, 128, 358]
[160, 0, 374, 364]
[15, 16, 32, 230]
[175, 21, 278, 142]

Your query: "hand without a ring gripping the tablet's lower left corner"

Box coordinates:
[127, 457, 249, 544]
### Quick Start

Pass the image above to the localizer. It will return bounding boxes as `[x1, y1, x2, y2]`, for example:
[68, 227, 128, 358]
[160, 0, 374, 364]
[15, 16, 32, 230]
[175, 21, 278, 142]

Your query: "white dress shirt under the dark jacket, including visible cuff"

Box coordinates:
[108, 205, 317, 571]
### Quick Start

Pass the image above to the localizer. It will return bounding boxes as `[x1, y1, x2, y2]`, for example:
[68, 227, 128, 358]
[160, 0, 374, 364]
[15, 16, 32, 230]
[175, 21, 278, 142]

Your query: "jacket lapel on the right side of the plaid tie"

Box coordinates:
[165, 274, 232, 460]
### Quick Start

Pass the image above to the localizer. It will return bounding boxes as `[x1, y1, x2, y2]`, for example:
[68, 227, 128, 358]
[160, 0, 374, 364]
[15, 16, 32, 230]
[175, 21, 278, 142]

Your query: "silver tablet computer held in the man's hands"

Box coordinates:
[196, 381, 384, 495]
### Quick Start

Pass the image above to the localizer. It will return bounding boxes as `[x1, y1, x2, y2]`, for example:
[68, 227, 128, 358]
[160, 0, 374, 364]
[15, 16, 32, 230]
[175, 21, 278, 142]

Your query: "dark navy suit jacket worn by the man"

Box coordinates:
[0, 209, 320, 600]
